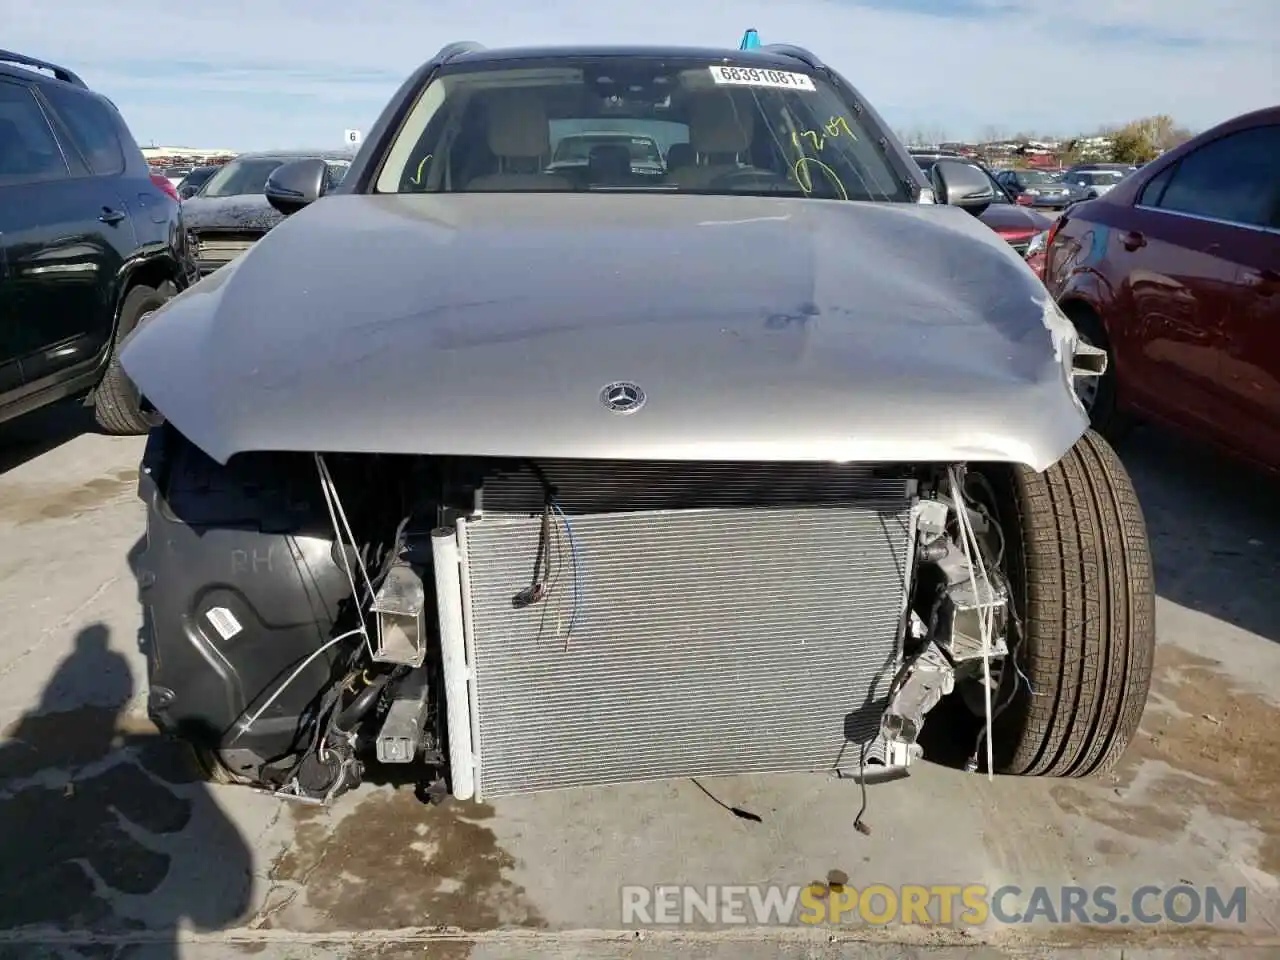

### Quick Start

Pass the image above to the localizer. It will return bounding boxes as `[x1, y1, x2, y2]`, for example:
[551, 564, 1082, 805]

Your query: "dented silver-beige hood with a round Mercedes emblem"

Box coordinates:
[120, 193, 1087, 468]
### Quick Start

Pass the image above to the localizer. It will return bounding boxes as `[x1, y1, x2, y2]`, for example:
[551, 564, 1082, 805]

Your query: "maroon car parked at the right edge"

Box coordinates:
[1044, 106, 1280, 472]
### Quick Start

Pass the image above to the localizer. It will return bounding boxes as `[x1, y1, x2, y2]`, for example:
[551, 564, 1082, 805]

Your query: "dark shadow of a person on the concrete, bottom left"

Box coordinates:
[0, 623, 253, 960]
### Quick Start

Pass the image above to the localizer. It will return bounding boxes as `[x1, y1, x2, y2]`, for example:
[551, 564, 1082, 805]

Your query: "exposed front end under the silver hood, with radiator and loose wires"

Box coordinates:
[138, 428, 1019, 803]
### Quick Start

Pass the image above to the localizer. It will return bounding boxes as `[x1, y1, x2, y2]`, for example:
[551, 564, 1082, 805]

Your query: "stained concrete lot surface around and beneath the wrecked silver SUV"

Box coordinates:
[0, 410, 1280, 960]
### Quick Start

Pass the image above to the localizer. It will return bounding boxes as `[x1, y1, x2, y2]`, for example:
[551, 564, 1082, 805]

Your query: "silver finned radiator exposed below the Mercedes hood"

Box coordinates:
[445, 462, 914, 797]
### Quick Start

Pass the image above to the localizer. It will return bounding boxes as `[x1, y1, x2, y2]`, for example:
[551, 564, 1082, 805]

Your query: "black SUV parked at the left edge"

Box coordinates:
[0, 50, 193, 434]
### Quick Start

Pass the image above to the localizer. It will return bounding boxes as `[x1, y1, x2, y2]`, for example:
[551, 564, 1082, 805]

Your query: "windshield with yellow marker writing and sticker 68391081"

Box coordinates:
[375, 56, 914, 202]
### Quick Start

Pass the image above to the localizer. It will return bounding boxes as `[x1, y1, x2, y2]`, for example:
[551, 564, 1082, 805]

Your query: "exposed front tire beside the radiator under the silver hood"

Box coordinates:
[992, 430, 1156, 777]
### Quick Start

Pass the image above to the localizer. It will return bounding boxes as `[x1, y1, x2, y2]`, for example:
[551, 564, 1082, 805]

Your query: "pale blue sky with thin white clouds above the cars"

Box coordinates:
[0, 0, 1280, 150]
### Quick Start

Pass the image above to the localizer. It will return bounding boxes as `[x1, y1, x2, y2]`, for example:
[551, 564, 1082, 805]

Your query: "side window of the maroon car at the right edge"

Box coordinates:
[1143, 124, 1280, 227]
